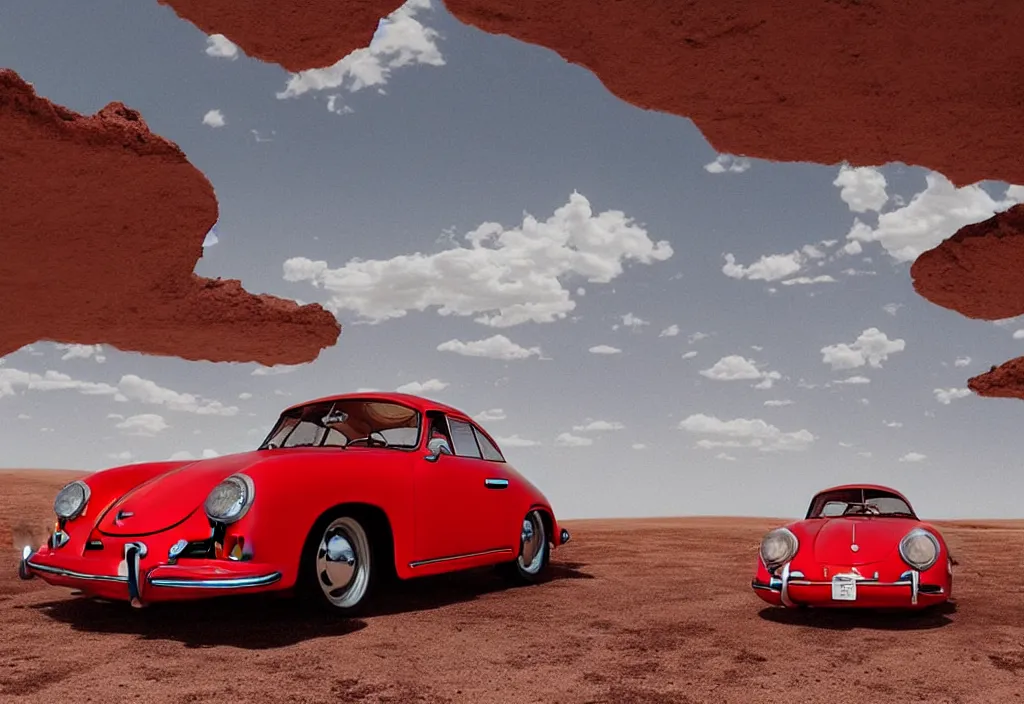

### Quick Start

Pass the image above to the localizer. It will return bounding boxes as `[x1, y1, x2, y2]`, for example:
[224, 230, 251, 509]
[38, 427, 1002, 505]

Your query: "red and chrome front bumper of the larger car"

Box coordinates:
[17, 540, 282, 607]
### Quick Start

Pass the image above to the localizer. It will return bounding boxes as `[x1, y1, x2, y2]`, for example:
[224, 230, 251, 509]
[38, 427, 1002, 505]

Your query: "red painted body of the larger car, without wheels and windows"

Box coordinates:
[22, 393, 569, 606]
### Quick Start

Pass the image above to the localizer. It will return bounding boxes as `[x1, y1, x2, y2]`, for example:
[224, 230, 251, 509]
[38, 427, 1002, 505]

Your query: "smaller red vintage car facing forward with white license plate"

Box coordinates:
[751, 484, 953, 609]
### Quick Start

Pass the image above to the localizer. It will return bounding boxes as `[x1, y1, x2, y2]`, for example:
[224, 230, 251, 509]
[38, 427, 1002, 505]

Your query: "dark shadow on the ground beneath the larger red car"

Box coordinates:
[28, 562, 593, 650]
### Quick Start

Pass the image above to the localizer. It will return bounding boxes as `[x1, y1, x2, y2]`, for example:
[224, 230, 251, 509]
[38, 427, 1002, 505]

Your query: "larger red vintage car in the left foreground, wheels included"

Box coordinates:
[19, 393, 569, 614]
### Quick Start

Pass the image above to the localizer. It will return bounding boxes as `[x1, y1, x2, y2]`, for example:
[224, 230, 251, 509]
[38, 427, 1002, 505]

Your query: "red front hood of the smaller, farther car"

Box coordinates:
[814, 517, 918, 565]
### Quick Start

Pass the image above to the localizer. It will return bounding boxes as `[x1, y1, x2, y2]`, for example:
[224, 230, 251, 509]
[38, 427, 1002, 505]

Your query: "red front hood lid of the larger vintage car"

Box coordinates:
[97, 452, 265, 536]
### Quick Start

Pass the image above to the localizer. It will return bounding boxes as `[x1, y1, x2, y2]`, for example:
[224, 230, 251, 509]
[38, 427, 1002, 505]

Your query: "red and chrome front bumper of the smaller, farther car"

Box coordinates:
[751, 563, 946, 607]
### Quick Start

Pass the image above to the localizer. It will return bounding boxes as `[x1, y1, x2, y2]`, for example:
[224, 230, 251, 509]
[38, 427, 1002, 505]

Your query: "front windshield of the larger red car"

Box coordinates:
[259, 399, 420, 450]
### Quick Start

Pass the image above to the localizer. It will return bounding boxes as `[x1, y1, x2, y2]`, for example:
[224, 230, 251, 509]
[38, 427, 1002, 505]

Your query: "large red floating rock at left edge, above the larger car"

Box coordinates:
[0, 70, 341, 364]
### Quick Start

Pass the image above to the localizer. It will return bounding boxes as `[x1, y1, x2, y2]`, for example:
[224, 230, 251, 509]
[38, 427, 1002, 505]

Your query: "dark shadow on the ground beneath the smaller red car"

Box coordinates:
[758, 602, 956, 630]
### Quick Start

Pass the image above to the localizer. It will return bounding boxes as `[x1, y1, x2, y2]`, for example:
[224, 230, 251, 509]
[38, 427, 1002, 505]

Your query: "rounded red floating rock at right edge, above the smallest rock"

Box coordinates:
[910, 205, 1024, 320]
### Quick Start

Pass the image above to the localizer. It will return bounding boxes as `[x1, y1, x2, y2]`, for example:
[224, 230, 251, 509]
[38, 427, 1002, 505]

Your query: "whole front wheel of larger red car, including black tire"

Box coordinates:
[297, 511, 382, 617]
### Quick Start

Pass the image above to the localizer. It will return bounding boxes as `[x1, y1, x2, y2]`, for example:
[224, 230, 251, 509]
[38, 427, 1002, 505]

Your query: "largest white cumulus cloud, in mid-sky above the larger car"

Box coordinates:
[284, 192, 673, 327]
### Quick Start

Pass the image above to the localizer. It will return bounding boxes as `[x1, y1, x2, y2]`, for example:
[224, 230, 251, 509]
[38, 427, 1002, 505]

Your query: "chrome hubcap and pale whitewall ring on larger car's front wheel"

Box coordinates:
[316, 517, 370, 608]
